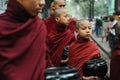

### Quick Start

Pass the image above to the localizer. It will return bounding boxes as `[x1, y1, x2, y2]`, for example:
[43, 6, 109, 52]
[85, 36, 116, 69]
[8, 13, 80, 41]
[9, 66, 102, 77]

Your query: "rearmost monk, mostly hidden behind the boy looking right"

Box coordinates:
[44, 0, 76, 33]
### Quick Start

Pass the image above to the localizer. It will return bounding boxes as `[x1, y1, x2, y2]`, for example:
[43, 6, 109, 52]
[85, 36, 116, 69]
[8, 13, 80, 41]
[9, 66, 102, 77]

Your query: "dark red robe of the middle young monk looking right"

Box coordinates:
[47, 24, 75, 66]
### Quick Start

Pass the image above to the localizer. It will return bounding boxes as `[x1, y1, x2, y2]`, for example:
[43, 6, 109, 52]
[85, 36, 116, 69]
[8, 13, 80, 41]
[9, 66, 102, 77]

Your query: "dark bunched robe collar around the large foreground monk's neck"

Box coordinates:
[6, 0, 31, 22]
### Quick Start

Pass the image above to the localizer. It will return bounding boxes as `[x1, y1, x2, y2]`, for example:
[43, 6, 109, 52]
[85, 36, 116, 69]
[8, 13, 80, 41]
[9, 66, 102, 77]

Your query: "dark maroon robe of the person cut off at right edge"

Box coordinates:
[110, 42, 120, 80]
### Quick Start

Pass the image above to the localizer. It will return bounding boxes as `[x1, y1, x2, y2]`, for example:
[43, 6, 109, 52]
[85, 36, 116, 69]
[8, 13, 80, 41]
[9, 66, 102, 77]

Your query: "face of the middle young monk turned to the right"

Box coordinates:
[56, 11, 69, 25]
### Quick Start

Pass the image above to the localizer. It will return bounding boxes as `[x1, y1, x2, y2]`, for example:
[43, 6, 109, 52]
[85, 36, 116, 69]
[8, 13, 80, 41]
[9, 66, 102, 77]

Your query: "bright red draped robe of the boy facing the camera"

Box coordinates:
[68, 36, 100, 76]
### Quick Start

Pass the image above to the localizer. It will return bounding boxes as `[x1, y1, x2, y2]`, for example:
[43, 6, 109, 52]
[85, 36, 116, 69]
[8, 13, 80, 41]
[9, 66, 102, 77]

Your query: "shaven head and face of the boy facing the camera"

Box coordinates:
[77, 21, 92, 39]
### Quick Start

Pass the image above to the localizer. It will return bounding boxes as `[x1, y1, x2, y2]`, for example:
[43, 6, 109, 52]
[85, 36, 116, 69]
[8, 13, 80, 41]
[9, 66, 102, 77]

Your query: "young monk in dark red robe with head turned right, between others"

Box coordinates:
[47, 8, 74, 66]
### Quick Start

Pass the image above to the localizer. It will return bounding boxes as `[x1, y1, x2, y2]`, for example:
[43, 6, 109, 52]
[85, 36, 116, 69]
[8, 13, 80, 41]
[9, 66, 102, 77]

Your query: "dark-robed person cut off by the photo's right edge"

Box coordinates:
[110, 21, 120, 80]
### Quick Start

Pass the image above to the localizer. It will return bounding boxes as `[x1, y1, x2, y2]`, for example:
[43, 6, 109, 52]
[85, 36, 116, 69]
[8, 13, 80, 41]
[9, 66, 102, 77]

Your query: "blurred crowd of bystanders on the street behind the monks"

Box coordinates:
[90, 12, 119, 52]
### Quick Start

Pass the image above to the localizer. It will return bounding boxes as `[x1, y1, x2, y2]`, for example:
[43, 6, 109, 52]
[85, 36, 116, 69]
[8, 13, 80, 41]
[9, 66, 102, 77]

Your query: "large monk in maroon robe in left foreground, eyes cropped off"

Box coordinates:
[0, 0, 47, 80]
